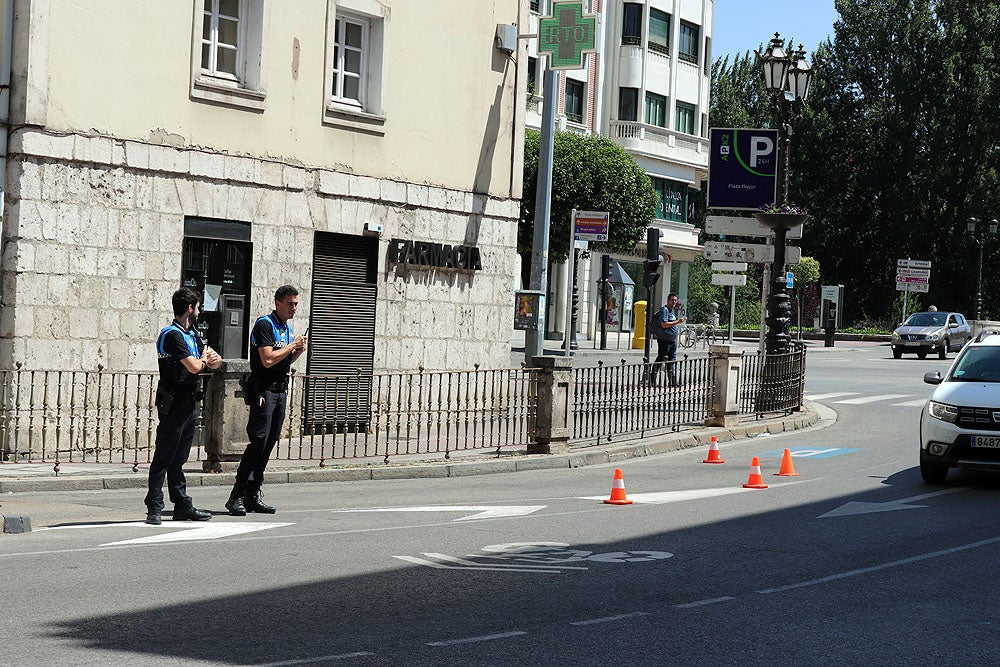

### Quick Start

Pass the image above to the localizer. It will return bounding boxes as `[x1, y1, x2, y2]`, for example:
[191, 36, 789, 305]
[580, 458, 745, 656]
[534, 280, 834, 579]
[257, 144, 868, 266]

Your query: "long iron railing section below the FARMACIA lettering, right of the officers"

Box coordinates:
[266, 367, 538, 464]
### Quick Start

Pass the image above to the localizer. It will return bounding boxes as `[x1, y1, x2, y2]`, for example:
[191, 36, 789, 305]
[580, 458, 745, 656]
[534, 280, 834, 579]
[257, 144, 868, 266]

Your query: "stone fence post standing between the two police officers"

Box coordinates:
[202, 359, 250, 472]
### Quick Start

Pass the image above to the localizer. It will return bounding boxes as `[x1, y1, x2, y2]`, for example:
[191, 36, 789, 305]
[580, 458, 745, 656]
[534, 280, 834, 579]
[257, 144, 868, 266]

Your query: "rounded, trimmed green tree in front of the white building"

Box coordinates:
[517, 130, 659, 266]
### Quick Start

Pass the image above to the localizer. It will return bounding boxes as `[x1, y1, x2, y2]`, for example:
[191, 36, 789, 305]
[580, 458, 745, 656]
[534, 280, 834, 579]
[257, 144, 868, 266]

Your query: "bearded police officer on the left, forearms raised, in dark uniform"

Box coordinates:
[145, 287, 222, 525]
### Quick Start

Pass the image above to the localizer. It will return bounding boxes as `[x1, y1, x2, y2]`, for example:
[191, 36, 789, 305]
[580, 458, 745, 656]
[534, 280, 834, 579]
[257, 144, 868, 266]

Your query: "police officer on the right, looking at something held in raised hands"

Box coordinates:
[226, 285, 306, 516]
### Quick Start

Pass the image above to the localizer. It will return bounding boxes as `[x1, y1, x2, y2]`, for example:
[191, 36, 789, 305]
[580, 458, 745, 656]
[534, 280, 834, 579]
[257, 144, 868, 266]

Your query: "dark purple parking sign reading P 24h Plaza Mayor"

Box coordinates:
[708, 127, 778, 209]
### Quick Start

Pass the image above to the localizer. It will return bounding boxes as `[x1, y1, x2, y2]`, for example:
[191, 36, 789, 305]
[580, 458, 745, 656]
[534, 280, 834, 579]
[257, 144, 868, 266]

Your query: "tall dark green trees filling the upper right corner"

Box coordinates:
[791, 0, 1000, 322]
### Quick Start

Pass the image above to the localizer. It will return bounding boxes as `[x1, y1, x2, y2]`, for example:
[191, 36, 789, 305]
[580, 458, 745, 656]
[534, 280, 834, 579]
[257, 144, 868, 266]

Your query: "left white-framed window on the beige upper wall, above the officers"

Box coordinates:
[191, 0, 268, 110]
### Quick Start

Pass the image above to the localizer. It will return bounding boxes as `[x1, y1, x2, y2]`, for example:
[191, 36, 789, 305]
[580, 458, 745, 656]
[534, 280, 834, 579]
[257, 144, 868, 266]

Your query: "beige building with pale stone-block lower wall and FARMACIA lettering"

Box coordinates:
[0, 0, 529, 373]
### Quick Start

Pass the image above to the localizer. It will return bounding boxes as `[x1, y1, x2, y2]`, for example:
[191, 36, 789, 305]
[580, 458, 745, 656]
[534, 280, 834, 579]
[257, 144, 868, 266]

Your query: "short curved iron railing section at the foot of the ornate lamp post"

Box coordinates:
[739, 343, 806, 418]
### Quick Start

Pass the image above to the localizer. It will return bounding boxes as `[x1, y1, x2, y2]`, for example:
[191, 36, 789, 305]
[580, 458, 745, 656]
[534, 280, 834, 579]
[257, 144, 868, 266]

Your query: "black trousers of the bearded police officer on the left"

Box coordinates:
[145, 393, 195, 512]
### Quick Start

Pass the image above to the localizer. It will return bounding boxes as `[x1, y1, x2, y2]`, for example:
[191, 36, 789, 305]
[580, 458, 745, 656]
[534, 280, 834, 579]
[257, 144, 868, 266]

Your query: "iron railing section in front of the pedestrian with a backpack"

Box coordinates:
[573, 358, 715, 444]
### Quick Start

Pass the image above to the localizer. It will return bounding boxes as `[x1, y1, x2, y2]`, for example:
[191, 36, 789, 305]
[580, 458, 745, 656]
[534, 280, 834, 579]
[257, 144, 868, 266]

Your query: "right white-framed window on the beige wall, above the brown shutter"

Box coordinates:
[323, 0, 389, 133]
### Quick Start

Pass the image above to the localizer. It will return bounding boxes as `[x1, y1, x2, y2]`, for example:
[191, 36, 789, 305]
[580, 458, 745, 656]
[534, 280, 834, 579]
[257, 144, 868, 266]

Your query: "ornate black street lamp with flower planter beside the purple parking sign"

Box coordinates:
[755, 33, 814, 355]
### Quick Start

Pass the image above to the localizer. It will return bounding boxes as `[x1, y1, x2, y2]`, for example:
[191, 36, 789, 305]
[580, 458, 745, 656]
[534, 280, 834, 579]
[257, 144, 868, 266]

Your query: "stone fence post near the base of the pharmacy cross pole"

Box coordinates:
[528, 357, 573, 454]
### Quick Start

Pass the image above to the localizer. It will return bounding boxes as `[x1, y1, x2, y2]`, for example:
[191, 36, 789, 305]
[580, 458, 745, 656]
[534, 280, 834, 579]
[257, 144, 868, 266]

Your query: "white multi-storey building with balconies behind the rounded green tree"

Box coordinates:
[526, 0, 714, 337]
